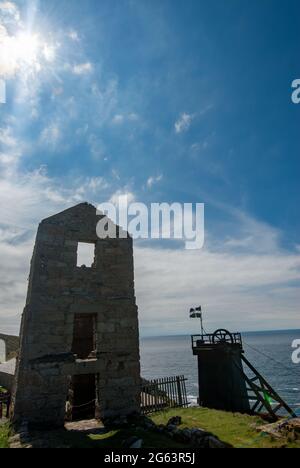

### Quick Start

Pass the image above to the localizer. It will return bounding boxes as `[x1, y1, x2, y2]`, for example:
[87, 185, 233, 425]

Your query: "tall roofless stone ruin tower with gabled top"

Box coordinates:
[11, 203, 140, 427]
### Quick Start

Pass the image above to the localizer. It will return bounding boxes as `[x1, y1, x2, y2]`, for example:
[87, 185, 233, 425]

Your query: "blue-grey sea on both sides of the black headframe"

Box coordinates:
[141, 330, 300, 416]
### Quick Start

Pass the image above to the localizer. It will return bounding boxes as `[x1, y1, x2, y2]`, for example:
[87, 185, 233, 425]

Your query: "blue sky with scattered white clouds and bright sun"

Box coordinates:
[0, 0, 300, 335]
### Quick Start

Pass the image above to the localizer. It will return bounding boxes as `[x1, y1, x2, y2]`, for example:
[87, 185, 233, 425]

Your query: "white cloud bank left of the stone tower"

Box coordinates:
[0, 128, 113, 333]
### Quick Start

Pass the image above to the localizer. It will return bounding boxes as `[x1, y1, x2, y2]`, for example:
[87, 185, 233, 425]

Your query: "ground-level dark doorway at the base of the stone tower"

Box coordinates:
[69, 374, 96, 421]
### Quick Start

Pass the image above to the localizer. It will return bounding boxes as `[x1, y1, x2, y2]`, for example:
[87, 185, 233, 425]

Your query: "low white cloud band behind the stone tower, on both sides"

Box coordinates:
[0, 149, 300, 334]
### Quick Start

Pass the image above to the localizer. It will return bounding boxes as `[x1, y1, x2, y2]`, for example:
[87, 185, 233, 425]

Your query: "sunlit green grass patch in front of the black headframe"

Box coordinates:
[152, 408, 300, 448]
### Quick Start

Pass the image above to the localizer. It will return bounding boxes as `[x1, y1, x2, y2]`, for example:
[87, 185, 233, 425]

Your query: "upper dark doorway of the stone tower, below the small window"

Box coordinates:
[72, 314, 96, 359]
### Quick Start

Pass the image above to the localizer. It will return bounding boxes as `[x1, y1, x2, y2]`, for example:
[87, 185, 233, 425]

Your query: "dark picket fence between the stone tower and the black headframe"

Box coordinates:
[141, 375, 189, 414]
